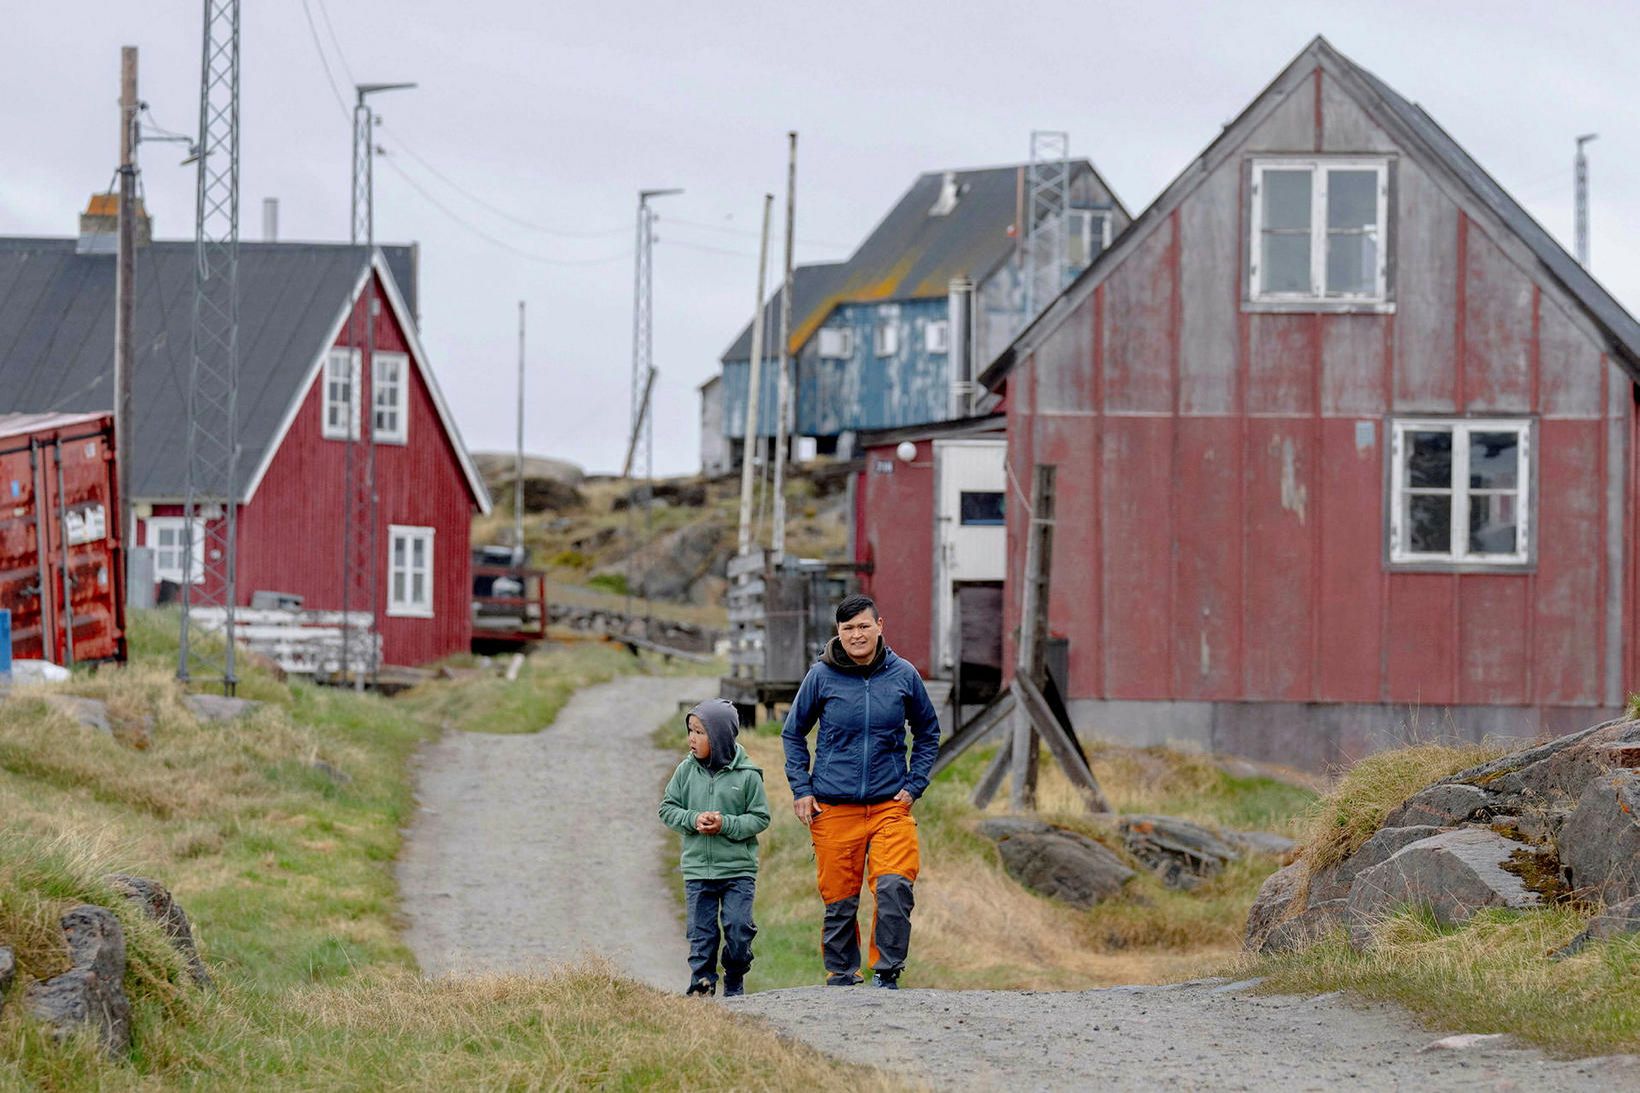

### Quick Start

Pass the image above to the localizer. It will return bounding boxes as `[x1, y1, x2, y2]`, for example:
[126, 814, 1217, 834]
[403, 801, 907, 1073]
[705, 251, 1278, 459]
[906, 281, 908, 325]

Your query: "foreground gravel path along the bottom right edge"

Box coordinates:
[723, 980, 1640, 1093]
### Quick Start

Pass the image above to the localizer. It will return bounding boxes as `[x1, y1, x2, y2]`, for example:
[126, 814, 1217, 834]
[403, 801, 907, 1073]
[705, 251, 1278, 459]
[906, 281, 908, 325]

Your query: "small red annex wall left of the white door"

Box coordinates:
[854, 440, 935, 673]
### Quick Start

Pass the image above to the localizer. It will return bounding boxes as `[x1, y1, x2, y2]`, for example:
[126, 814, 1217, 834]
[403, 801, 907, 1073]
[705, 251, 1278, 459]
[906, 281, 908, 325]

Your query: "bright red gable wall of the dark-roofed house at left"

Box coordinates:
[238, 272, 474, 665]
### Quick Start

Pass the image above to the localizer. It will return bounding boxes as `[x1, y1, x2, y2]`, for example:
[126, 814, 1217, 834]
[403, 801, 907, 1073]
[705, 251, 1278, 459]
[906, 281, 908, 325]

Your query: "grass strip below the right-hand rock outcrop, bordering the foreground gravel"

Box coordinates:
[1243, 906, 1640, 1055]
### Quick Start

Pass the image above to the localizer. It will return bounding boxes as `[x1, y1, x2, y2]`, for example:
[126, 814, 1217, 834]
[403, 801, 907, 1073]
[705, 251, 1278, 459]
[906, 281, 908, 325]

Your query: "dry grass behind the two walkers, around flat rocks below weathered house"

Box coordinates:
[658, 725, 1312, 990]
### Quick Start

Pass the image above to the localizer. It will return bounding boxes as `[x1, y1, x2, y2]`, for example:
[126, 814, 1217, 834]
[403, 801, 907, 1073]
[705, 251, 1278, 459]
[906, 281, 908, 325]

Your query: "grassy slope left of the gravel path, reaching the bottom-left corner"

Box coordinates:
[0, 615, 869, 1090]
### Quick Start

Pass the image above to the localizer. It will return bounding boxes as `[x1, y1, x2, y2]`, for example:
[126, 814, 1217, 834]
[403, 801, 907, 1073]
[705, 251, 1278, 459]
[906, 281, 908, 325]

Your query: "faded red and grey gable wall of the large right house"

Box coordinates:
[1004, 66, 1640, 707]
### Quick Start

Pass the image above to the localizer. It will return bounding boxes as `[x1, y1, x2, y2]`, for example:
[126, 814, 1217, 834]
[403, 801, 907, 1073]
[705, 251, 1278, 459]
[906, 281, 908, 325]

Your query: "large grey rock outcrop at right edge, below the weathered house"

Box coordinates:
[1243, 720, 1640, 952]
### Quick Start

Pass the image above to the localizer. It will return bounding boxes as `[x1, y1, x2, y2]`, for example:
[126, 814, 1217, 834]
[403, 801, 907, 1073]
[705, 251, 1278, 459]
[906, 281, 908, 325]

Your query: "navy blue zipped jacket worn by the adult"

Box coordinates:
[781, 638, 940, 804]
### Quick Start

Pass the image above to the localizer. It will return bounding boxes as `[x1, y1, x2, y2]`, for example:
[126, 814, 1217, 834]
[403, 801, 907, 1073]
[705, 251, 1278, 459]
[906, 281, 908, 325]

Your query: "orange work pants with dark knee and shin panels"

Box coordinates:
[809, 801, 920, 976]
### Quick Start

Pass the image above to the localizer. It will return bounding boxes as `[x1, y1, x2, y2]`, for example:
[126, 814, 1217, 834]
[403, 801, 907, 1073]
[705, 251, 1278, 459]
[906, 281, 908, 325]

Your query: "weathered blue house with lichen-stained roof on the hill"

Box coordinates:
[702, 159, 1130, 469]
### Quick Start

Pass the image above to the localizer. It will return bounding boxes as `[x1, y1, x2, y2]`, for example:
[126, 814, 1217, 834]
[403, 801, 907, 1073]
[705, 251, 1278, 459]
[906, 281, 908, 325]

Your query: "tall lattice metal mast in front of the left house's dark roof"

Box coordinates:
[177, 0, 239, 696]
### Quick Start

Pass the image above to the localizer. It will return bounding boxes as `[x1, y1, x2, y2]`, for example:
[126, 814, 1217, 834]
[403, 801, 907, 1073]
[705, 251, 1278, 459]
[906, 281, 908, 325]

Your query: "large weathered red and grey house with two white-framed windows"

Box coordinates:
[984, 38, 1640, 766]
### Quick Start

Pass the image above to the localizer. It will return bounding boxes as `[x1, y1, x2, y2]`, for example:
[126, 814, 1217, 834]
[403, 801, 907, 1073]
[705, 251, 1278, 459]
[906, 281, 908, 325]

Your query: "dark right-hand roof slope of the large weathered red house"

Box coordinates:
[1314, 45, 1640, 371]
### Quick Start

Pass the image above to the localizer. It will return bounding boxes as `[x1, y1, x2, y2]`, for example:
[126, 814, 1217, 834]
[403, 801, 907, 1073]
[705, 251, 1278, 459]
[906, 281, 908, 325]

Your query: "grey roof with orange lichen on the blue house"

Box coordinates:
[723, 159, 1127, 361]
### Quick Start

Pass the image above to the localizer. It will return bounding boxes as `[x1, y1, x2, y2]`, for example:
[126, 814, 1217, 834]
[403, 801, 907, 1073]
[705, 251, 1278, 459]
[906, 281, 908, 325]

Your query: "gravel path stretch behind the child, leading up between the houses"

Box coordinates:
[399, 676, 713, 990]
